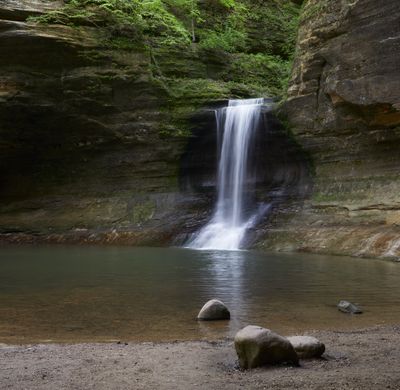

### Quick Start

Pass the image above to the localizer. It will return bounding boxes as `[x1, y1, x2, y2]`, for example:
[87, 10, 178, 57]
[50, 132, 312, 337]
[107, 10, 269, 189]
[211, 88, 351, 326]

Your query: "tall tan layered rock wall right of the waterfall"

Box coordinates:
[265, 0, 400, 258]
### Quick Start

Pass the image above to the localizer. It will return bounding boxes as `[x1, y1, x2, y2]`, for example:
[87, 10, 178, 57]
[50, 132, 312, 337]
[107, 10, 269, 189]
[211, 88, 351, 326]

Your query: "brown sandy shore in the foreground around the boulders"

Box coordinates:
[0, 326, 400, 390]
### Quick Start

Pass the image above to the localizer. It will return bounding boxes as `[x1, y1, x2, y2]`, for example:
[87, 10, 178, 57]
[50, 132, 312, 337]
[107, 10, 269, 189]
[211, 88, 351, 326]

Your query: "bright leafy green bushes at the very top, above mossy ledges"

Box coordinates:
[31, 0, 299, 69]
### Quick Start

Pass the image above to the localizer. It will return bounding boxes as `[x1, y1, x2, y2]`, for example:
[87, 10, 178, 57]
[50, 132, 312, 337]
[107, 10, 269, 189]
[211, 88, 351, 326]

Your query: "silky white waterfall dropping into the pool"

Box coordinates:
[188, 99, 264, 250]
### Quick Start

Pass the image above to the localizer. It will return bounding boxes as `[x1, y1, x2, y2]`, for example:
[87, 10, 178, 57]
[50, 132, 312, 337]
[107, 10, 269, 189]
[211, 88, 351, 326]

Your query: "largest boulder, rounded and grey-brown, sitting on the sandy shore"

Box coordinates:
[235, 325, 299, 368]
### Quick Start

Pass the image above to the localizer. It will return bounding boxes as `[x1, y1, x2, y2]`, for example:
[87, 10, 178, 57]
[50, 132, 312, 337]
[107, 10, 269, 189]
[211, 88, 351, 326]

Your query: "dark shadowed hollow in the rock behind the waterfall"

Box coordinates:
[180, 106, 311, 198]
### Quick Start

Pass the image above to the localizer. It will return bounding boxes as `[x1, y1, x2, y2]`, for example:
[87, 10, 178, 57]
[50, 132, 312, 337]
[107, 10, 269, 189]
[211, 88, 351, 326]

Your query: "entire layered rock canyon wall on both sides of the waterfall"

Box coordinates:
[0, 0, 400, 259]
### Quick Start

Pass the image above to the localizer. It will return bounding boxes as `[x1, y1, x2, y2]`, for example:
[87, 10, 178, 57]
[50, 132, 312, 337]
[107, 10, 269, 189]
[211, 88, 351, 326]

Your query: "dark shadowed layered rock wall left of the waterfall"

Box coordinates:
[0, 0, 200, 244]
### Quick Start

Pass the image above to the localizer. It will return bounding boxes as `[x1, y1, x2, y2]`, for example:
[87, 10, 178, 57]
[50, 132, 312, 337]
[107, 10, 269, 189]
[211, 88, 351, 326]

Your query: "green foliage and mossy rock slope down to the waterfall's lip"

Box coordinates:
[31, 0, 300, 134]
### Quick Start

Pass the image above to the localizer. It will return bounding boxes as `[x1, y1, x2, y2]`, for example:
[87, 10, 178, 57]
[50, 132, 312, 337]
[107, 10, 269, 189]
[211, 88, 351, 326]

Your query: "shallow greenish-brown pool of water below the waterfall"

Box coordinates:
[0, 247, 400, 343]
